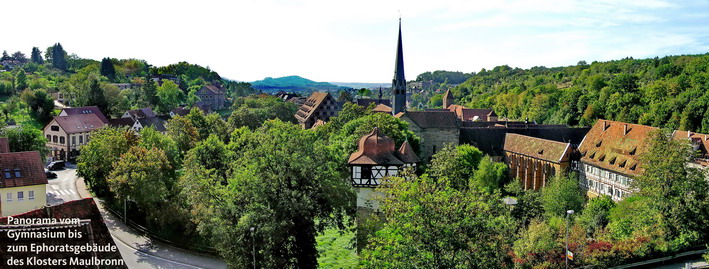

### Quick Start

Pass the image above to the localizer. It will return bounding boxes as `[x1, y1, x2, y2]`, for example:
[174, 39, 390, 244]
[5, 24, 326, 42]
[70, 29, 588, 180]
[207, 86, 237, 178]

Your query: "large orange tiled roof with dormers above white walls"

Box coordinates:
[579, 120, 658, 176]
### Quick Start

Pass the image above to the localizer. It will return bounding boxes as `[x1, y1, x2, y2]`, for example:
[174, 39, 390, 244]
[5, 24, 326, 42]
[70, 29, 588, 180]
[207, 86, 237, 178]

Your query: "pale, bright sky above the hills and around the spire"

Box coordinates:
[0, 0, 709, 83]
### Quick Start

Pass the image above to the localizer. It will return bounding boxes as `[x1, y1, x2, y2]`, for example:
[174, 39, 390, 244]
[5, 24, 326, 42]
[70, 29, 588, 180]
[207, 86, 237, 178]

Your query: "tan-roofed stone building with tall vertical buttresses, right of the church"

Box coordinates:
[504, 133, 573, 190]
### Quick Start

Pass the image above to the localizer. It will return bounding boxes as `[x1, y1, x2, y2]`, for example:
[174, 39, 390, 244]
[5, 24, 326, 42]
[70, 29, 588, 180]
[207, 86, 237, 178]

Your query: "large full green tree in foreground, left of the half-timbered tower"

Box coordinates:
[180, 120, 355, 268]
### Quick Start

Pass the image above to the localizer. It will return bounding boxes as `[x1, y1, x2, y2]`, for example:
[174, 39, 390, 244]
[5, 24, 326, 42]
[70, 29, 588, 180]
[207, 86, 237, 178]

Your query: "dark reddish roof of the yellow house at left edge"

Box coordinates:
[0, 151, 47, 188]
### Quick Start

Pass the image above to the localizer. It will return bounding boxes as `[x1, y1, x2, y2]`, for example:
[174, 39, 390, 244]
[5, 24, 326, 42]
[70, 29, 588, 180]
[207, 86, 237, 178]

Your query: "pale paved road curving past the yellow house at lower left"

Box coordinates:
[47, 163, 226, 269]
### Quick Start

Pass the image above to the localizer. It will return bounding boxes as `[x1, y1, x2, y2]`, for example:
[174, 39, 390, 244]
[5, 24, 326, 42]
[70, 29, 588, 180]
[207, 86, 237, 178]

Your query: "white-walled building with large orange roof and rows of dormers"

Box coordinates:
[572, 120, 657, 201]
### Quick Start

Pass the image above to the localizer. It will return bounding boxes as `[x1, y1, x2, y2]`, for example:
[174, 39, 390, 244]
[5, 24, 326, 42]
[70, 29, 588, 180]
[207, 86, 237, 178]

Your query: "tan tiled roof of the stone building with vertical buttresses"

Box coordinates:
[504, 133, 571, 163]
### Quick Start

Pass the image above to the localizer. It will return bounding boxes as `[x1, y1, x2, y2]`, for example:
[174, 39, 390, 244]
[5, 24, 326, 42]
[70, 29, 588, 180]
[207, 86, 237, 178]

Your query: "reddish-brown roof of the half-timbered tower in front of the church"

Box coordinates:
[347, 127, 404, 165]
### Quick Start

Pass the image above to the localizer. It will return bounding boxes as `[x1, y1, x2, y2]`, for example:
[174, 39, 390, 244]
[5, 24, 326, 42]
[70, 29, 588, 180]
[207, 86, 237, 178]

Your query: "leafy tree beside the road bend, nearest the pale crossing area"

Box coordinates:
[76, 127, 138, 197]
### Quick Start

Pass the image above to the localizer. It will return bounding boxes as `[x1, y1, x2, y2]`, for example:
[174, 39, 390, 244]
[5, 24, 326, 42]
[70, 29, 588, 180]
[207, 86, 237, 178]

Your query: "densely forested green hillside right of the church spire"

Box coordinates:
[453, 54, 709, 132]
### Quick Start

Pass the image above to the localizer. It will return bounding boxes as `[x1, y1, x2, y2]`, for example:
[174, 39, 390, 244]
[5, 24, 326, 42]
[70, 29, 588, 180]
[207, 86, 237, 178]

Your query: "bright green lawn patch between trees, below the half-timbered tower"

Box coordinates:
[316, 225, 359, 268]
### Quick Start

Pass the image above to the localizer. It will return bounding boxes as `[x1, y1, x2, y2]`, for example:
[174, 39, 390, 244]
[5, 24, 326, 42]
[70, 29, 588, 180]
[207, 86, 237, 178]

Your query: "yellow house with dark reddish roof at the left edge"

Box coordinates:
[0, 151, 47, 216]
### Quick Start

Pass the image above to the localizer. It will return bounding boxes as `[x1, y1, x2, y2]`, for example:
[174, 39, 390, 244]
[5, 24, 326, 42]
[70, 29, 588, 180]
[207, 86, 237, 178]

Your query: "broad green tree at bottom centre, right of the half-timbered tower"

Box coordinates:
[361, 175, 515, 268]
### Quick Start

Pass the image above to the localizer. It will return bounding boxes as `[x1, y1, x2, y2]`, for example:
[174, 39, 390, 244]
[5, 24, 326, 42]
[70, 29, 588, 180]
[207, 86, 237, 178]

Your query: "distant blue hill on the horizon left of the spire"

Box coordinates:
[251, 76, 350, 92]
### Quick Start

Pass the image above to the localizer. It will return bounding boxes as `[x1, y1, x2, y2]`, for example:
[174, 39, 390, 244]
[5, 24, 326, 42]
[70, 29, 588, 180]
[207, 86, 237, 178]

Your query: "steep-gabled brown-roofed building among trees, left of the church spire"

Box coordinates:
[295, 92, 340, 129]
